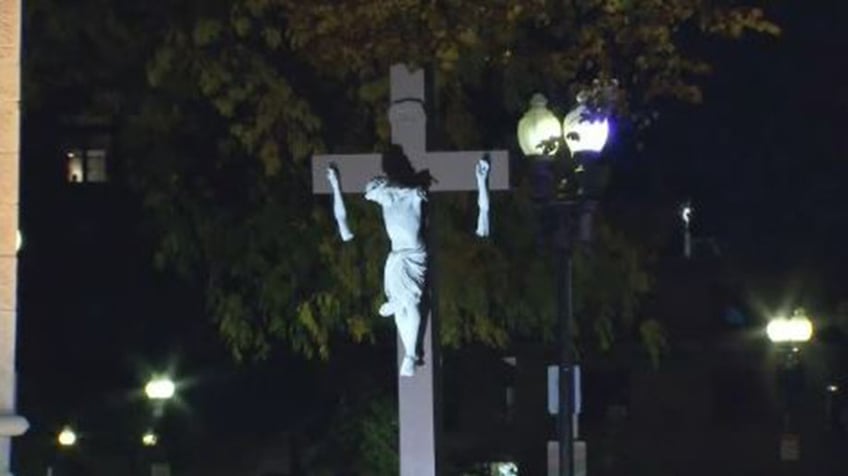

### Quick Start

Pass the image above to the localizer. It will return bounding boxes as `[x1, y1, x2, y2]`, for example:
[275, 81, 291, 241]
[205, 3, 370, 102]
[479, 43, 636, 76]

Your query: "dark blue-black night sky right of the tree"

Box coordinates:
[627, 2, 848, 300]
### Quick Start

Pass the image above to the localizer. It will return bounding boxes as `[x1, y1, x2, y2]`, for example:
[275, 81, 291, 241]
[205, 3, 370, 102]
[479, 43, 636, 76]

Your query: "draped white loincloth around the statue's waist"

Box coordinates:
[383, 248, 427, 308]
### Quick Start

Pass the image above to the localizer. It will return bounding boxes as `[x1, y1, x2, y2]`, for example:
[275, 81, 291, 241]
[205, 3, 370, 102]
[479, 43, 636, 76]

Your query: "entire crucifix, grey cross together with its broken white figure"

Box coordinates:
[312, 64, 509, 476]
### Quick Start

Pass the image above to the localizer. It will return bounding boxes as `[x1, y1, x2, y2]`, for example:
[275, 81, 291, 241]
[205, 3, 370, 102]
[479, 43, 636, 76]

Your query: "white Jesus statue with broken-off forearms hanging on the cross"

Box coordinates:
[327, 151, 490, 377]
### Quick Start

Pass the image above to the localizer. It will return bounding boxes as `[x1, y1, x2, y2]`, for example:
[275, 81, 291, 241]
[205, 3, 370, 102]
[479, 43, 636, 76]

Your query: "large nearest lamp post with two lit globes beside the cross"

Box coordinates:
[518, 89, 609, 476]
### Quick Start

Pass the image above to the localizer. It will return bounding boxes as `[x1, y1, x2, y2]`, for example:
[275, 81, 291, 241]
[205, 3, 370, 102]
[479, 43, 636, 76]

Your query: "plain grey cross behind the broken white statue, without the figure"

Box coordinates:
[312, 65, 509, 476]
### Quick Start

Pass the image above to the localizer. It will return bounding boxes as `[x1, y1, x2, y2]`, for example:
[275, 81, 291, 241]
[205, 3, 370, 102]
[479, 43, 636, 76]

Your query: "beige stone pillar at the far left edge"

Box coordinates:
[0, 0, 28, 476]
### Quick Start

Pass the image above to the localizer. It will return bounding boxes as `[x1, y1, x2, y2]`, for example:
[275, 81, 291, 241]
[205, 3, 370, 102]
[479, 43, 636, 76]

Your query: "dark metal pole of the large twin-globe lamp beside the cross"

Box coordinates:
[557, 204, 574, 476]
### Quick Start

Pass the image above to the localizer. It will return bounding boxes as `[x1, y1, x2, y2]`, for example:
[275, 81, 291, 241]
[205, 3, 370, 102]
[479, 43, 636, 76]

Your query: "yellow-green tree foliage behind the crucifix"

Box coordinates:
[28, 0, 778, 356]
